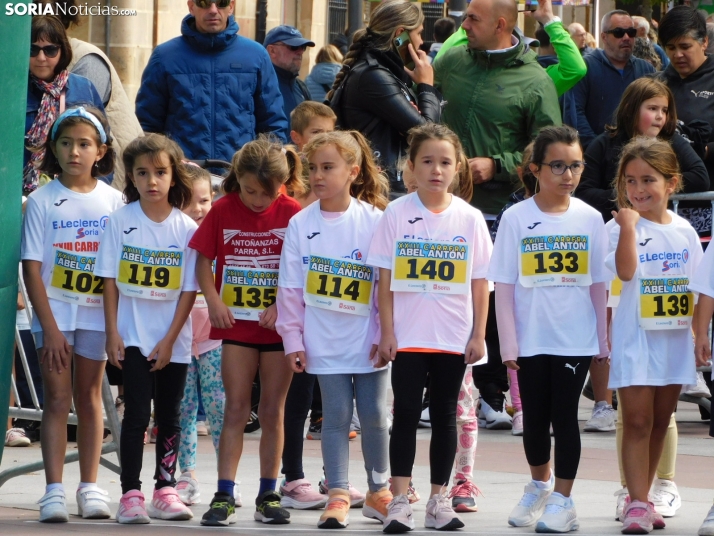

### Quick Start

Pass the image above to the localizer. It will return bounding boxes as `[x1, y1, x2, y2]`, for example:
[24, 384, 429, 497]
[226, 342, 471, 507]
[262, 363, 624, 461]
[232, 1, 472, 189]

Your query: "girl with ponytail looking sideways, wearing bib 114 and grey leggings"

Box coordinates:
[275, 131, 392, 528]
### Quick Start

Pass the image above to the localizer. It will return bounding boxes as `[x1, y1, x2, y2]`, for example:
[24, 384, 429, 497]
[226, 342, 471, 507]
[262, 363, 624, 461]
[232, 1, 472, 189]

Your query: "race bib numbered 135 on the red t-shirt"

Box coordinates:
[221, 266, 278, 322]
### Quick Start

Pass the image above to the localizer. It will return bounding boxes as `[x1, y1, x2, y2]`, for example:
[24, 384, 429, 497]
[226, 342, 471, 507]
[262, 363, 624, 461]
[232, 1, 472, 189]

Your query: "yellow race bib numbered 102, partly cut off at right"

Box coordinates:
[47, 248, 104, 307]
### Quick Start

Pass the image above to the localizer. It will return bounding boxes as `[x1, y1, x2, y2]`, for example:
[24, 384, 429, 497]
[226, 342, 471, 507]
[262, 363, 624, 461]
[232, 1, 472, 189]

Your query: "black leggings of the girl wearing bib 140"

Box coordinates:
[389, 352, 466, 485]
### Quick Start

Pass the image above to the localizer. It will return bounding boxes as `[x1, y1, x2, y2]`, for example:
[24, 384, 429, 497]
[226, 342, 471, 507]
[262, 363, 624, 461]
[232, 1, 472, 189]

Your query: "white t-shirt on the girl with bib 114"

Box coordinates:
[278, 199, 382, 374]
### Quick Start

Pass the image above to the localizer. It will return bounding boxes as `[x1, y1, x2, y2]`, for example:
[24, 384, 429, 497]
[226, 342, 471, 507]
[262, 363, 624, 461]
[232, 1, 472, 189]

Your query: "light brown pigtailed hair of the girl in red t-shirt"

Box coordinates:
[223, 134, 305, 198]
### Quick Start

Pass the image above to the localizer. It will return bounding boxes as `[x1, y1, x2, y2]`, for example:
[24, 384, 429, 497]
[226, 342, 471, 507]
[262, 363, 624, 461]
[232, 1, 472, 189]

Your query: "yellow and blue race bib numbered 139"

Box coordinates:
[639, 276, 694, 330]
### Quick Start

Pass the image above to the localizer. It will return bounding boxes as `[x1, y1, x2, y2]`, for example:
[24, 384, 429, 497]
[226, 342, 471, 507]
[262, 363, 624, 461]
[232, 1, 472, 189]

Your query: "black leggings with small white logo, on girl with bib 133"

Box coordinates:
[518, 355, 592, 480]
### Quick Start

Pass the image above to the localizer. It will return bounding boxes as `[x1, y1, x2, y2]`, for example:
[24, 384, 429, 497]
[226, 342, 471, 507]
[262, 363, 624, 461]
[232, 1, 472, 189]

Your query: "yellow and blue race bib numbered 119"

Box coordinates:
[117, 244, 186, 300]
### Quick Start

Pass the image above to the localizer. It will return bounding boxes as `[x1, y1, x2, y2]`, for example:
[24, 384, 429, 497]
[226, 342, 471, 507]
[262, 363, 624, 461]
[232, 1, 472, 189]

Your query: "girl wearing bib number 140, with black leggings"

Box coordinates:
[367, 124, 492, 532]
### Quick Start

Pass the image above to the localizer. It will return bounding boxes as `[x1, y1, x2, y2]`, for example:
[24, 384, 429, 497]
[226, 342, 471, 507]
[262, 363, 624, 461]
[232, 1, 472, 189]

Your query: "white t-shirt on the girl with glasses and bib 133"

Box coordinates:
[488, 198, 612, 357]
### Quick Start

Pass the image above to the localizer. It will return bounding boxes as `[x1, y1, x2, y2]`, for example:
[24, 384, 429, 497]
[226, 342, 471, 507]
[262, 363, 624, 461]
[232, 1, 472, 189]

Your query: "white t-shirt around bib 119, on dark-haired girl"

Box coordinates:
[95, 201, 198, 363]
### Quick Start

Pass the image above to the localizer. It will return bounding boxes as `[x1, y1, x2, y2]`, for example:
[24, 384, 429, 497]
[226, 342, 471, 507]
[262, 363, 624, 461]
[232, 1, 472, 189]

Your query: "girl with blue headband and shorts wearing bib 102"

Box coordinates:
[22, 107, 123, 522]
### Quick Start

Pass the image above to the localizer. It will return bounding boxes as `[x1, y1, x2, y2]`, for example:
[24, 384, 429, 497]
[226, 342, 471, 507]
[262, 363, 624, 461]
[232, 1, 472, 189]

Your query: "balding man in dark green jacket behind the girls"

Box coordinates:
[434, 0, 570, 219]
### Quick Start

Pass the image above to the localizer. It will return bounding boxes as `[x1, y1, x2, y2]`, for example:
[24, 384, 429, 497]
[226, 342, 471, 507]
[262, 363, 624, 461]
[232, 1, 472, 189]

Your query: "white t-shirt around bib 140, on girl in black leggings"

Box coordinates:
[367, 193, 493, 359]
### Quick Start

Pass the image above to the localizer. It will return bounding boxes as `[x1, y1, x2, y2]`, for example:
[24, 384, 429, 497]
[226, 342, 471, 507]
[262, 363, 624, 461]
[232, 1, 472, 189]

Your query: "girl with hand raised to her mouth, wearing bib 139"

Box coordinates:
[606, 138, 702, 534]
